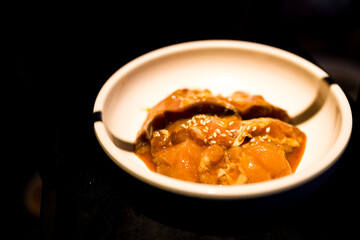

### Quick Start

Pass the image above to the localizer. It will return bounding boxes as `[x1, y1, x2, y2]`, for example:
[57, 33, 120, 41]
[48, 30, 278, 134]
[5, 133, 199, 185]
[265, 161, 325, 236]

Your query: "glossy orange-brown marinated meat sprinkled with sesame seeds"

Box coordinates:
[135, 89, 306, 185]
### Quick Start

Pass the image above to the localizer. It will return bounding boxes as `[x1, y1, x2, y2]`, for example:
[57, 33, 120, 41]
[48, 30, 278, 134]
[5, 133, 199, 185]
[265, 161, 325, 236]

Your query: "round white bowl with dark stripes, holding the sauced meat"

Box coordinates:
[94, 40, 352, 199]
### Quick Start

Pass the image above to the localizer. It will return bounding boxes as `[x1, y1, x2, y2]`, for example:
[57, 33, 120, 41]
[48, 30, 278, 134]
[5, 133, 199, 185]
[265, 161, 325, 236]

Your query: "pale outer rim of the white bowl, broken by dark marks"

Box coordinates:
[93, 40, 352, 199]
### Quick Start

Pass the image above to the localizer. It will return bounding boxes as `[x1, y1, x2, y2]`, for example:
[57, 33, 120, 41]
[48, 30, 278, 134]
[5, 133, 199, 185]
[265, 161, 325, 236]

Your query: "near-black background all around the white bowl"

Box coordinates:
[7, 0, 360, 239]
